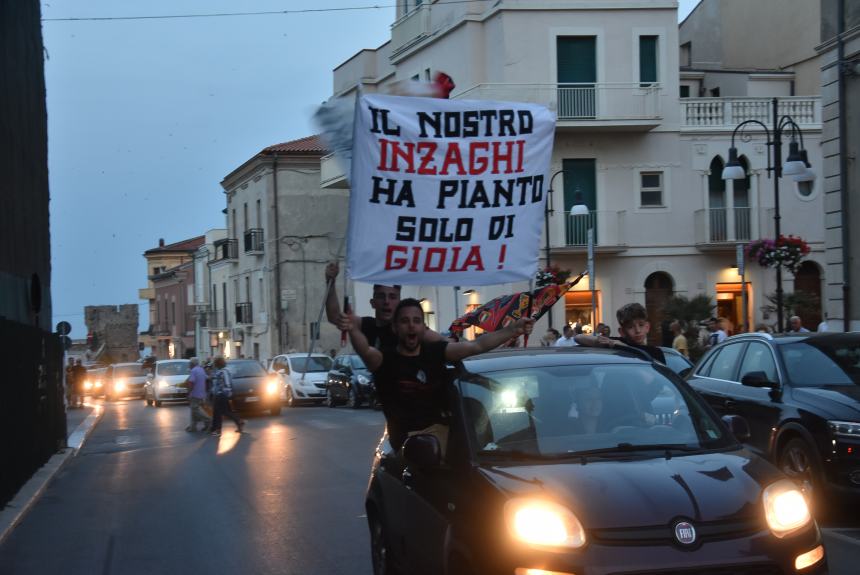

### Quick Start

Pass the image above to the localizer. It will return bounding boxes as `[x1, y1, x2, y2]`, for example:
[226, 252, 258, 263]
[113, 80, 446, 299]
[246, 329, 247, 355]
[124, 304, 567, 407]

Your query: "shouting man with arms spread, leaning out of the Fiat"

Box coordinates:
[338, 298, 534, 457]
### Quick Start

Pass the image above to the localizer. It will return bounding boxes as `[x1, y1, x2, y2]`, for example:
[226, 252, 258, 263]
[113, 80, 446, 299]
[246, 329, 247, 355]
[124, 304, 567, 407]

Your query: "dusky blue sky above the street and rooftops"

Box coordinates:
[42, 0, 697, 338]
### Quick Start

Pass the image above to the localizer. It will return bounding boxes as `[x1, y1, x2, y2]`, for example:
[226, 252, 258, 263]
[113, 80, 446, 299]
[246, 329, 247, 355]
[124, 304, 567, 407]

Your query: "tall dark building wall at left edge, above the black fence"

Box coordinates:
[0, 0, 53, 331]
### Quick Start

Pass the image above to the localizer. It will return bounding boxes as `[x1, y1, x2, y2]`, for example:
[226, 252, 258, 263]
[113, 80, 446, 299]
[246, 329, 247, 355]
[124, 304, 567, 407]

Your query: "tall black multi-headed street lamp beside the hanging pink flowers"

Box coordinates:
[722, 98, 815, 332]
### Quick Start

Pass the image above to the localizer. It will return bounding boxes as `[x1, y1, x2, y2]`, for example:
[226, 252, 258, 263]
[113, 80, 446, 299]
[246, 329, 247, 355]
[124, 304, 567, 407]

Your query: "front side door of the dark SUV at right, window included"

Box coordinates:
[728, 341, 782, 457]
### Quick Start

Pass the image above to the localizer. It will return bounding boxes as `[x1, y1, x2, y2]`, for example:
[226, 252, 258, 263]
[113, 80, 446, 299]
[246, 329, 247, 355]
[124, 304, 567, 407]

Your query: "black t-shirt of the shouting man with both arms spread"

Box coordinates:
[373, 341, 448, 449]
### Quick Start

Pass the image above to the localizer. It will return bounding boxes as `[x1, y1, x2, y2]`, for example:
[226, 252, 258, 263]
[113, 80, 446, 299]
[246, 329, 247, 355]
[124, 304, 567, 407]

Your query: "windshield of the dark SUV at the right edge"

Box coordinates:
[780, 337, 860, 387]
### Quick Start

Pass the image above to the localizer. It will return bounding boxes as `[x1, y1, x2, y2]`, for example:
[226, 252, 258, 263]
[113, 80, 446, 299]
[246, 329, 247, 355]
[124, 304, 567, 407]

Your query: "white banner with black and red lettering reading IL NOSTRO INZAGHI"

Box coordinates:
[347, 94, 555, 285]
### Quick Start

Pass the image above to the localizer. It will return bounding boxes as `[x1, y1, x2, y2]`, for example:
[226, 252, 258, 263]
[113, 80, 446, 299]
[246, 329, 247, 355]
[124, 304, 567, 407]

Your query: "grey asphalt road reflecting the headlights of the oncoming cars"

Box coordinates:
[0, 401, 860, 575]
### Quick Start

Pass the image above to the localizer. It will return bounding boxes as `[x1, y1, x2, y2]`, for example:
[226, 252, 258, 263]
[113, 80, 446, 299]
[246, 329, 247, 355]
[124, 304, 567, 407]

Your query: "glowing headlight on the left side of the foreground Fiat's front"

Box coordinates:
[505, 499, 585, 549]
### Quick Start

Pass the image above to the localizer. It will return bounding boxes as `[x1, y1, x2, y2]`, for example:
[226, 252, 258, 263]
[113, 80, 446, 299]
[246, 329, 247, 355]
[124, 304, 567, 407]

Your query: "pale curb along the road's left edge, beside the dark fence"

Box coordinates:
[0, 405, 104, 545]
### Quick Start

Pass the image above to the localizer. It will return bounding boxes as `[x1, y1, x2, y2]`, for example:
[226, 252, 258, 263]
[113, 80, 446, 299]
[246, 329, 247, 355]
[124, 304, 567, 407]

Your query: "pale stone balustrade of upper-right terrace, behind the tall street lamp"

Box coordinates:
[680, 96, 821, 131]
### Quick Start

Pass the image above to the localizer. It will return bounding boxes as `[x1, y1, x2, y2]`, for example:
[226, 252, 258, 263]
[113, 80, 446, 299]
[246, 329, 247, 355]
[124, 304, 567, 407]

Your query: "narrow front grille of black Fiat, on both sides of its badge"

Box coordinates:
[591, 519, 763, 545]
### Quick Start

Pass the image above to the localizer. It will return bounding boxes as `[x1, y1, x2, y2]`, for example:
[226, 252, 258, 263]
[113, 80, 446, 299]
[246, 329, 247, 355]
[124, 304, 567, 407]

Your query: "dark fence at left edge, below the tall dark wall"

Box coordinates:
[0, 320, 66, 508]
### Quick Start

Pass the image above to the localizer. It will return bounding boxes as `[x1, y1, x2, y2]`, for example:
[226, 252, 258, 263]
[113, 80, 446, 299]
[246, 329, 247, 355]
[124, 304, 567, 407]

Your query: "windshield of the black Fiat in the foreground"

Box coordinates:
[459, 364, 736, 459]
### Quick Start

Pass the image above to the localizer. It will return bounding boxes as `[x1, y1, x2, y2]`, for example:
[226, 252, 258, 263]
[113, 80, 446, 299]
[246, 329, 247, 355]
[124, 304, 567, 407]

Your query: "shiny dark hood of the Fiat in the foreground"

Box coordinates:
[481, 449, 783, 529]
